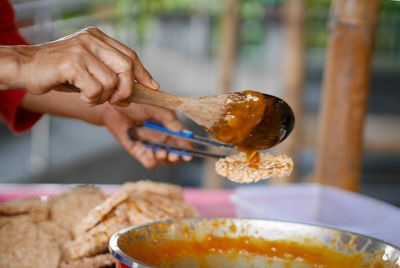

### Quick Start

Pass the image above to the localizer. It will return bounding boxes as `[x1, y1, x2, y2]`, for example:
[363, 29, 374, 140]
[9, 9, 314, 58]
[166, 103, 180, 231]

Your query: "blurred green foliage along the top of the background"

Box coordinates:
[60, 0, 400, 53]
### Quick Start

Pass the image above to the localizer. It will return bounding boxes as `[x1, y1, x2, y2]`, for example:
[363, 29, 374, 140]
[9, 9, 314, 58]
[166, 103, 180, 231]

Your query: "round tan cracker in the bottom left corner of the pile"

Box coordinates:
[0, 220, 60, 268]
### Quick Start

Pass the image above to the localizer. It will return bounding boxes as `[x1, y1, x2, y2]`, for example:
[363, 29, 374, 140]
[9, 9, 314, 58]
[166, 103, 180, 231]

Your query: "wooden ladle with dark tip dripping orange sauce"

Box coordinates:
[128, 83, 294, 151]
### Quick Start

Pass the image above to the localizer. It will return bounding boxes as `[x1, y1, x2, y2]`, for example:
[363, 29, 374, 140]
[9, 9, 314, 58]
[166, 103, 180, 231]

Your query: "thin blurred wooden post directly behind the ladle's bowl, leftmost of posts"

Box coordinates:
[204, 0, 241, 188]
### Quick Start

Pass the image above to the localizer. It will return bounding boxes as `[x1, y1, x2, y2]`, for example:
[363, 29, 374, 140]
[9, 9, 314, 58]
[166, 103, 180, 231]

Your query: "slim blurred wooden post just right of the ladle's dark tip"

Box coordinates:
[271, 0, 306, 183]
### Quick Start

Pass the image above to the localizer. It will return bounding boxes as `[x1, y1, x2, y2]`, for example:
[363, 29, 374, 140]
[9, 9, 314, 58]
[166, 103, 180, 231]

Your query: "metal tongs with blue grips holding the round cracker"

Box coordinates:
[128, 122, 235, 158]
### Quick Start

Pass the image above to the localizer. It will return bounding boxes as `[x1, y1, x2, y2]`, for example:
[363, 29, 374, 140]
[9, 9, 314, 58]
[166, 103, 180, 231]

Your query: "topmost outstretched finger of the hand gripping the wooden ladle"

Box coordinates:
[85, 27, 160, 89]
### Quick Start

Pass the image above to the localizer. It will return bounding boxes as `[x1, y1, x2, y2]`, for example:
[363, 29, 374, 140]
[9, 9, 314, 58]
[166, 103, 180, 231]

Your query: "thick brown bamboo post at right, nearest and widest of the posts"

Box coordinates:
[315, 0, 379, 191]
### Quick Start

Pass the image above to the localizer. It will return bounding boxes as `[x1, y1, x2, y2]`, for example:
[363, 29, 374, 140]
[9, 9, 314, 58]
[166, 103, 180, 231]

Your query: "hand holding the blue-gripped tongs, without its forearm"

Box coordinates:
[101, 103, 192, 168]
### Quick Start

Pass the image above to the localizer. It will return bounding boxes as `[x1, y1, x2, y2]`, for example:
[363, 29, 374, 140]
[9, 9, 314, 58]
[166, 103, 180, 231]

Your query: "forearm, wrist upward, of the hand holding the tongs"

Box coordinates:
[21, 91, 105, 125]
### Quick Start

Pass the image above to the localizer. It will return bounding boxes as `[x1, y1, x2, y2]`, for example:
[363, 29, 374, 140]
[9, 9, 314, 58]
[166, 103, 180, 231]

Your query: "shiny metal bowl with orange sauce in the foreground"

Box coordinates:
[109, 218, 400, 268]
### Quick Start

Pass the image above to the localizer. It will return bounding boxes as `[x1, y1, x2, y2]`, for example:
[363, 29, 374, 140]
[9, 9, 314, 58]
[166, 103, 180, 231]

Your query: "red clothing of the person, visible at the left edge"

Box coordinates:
[0, 0, 41, 133]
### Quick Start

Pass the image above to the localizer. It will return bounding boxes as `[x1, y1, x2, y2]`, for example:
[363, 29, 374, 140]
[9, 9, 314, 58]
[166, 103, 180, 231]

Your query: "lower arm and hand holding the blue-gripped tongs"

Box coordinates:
[21, 91, 191, 168]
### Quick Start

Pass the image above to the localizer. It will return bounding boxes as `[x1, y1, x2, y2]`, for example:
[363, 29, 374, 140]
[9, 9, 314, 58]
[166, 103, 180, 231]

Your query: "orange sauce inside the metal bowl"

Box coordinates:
[126, 235, 385, 268]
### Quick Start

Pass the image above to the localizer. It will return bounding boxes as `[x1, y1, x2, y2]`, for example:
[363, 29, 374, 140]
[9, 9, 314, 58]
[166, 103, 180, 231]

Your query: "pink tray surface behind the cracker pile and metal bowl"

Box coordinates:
[0, 184, 235, 217]
